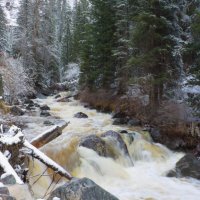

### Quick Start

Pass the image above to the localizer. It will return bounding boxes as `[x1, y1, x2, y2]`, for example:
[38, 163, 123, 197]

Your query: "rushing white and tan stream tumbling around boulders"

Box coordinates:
[27, 93, 200, 200]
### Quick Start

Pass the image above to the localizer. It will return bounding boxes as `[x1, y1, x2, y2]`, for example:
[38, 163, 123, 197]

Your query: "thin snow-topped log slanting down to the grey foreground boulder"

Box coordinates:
[24, 140, 73, 180]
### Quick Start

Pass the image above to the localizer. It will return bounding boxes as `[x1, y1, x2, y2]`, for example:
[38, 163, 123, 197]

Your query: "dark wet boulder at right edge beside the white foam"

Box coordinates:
[168, 154, 200, 180]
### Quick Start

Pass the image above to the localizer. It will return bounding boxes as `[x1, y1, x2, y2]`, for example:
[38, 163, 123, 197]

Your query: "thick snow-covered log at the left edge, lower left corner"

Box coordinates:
[0, 151, 24, 184]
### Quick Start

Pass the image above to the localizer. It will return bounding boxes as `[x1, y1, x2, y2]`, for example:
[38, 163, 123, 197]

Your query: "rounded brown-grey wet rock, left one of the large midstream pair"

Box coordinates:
[79, 135, 108, 157]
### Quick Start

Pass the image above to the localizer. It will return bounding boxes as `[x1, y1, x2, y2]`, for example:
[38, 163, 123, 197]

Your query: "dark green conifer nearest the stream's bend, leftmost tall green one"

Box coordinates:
[79, 0, 116, 88]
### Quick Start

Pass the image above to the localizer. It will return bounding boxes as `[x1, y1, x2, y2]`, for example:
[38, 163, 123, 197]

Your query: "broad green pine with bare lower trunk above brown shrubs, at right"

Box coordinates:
[129, 0, 179, 109]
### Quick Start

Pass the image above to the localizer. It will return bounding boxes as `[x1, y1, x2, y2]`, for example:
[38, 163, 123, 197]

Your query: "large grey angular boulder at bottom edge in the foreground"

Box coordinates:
[48, 178, 119, 200]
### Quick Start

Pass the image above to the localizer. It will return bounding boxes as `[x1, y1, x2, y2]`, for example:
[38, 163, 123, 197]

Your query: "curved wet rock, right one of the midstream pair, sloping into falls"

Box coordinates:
[101, 131, 129, 156]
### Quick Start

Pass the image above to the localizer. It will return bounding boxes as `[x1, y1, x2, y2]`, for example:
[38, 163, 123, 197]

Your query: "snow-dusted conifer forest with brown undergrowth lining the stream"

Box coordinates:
[0, 0, 200, 147]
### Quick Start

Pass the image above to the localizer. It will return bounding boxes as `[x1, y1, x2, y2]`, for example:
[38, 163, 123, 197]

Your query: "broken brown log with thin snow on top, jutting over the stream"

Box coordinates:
[31, 122, 69, 148]
